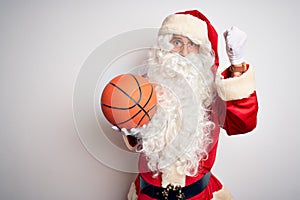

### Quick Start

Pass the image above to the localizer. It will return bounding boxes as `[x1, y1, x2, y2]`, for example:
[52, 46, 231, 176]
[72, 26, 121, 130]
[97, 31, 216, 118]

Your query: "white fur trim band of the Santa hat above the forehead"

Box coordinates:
[159, 14, 210, 45]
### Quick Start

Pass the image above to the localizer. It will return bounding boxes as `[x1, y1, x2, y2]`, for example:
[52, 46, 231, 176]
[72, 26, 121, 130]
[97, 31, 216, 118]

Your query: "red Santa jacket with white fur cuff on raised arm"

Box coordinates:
[135, 65, 258, 200]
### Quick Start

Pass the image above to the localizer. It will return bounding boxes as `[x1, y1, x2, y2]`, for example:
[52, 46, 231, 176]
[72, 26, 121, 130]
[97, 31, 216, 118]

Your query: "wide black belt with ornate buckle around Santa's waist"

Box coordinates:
[140, 172, 211, 200]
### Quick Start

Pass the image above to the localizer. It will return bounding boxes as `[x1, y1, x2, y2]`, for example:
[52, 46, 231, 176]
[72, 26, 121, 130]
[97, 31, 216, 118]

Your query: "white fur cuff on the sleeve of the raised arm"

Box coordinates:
[216, 66, 255, 101]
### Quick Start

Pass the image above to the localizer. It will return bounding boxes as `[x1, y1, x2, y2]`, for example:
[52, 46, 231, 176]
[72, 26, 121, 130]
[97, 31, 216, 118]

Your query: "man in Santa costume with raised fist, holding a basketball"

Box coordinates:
[122, 10, 258, 200]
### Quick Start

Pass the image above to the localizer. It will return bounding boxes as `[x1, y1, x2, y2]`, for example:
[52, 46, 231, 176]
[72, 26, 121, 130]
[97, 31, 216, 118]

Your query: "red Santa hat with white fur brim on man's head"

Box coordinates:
[158, 10, 219, 72]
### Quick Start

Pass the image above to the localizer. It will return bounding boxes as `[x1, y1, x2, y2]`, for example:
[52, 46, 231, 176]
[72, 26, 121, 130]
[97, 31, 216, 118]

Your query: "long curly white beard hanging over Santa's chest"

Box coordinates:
[140, 47, 214, 176]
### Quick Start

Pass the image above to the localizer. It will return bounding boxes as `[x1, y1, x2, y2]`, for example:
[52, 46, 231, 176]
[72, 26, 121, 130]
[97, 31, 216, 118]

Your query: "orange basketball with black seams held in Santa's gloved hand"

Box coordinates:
[101, 74, 157, 129]
